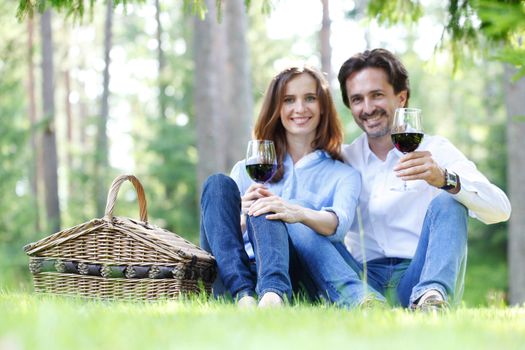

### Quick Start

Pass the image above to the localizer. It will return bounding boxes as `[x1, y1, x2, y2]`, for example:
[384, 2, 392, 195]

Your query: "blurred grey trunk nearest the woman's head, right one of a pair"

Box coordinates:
[223, 0, 253, 166]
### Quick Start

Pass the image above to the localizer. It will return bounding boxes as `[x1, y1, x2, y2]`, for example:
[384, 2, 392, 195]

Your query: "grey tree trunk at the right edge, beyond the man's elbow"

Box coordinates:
[505, 66, 525, 305]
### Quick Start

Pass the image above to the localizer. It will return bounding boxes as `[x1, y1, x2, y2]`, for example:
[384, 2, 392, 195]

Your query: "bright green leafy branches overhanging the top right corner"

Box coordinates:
[368, 0, 525, 78]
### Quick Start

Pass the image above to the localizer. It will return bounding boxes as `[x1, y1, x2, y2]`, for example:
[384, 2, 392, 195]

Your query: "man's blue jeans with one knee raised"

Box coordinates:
[337, 192, 467, 307]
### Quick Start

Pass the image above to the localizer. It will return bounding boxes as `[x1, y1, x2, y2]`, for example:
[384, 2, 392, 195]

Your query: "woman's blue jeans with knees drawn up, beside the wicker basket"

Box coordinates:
[200, 174, 312, 299]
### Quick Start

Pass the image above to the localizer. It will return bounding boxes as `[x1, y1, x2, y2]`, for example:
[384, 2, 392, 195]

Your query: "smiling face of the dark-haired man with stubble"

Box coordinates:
[346, 68, 407, 139]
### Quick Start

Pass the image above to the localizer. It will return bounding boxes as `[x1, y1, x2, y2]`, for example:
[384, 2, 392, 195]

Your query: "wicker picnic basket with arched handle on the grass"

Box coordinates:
[24, 175, 216, 300]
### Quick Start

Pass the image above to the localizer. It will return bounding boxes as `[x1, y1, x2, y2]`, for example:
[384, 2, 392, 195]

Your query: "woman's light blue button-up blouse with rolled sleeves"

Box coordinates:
[230, 150, 361, 258]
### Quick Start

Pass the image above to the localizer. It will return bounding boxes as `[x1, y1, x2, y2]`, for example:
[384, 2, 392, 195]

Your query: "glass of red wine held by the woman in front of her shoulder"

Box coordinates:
[246, 140, 277, 184]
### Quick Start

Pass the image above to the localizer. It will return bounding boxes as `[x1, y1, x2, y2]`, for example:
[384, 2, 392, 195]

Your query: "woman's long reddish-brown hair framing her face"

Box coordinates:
[253, 66, 343, 182]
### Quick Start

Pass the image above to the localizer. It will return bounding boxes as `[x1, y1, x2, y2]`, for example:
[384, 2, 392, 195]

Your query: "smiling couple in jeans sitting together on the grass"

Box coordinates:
[201, 49, 511, 310]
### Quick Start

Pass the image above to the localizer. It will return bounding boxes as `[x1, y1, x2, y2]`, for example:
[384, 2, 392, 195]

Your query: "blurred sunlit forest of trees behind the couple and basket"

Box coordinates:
[0, 0, 525, 305]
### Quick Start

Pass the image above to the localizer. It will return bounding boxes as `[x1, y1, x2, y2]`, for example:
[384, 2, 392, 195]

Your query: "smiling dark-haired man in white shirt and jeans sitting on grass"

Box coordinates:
[338, 49, 511, 309]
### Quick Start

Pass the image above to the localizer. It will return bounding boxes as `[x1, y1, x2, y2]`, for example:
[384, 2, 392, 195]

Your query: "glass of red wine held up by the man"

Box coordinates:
[391, 108, 424, 191]
